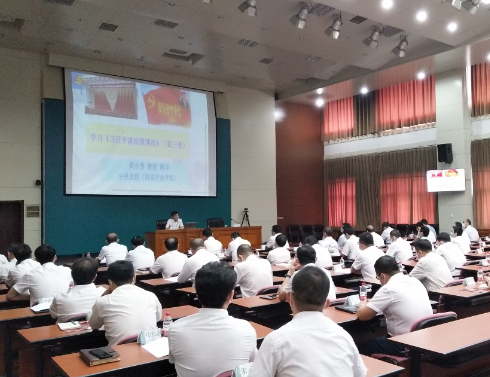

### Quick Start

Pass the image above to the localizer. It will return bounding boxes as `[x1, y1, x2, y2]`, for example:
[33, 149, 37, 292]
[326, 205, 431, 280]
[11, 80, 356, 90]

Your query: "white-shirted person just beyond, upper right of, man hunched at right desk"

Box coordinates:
[410, 240, 453, 291]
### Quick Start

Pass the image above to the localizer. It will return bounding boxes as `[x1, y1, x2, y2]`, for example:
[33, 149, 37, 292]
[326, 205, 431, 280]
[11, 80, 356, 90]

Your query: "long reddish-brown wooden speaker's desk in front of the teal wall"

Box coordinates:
[145, 226, 262, 258]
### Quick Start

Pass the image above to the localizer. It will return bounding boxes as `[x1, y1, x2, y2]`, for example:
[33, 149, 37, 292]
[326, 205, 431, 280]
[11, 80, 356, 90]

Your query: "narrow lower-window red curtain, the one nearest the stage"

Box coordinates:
[327, 178, 356, 227]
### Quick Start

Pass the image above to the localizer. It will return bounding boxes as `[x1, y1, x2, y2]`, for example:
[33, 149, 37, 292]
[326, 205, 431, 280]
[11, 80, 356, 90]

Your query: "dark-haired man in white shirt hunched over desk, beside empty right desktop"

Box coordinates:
[357, 254, 432, 356]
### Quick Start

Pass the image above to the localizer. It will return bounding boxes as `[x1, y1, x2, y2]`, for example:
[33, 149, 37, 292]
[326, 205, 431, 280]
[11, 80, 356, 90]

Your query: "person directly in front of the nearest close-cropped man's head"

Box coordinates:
[278, 245, 337, 301]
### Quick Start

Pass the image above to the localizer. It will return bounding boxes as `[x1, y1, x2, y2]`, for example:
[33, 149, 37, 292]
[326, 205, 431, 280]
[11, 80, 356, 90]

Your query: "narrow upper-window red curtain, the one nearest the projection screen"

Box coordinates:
[323, 97, 354, 140]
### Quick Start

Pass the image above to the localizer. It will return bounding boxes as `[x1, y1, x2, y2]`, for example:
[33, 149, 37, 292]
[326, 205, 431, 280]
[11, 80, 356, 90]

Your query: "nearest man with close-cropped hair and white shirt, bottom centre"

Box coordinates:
[248, 266, 367, 377]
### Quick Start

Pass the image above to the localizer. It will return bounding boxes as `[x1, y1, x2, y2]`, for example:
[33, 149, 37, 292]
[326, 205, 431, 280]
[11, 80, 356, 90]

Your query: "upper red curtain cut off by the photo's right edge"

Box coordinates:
[471, 63, 490, 117]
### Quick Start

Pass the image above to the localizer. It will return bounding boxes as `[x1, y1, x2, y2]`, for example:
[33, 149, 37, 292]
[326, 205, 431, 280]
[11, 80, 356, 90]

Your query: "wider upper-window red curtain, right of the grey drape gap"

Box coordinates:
[376, 76, 436, 131]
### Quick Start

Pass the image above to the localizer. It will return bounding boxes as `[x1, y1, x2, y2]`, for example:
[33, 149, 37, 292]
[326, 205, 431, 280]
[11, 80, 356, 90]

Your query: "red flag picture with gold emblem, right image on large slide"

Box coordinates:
[143, 88, 191, 127]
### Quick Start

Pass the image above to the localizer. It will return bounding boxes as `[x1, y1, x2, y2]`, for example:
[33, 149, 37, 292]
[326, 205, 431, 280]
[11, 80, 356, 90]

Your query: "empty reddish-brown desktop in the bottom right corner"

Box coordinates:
[389, 313, 490, 355]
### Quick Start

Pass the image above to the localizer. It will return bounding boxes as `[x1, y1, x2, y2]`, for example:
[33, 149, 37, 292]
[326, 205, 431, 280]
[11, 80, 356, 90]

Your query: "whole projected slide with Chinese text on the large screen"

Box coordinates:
[65, 70, 216, 196]
